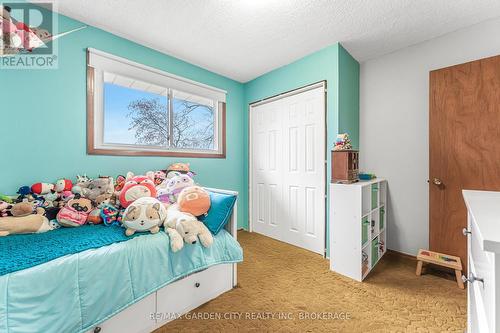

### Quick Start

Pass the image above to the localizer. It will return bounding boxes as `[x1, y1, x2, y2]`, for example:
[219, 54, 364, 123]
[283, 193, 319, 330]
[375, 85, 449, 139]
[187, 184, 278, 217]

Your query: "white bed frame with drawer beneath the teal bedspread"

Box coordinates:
[86, 188, 238, 333]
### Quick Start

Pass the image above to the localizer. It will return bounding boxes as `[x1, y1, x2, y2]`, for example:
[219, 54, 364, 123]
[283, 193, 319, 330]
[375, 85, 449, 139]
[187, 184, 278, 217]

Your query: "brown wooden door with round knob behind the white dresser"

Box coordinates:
[429, 56, 500, 268]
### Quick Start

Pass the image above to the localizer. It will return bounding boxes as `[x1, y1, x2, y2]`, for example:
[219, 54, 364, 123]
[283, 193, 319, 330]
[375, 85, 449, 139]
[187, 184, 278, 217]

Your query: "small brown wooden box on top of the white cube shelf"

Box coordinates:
[332, 150, 359, 183]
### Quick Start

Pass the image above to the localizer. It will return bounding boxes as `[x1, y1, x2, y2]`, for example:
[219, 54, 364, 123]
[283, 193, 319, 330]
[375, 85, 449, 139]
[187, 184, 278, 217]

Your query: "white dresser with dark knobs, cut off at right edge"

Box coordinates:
[462, 190, 500, 333]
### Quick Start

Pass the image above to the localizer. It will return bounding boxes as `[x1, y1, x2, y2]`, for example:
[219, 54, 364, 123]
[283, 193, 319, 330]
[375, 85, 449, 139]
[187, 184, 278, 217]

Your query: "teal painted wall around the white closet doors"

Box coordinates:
[242, 44, 359, 246]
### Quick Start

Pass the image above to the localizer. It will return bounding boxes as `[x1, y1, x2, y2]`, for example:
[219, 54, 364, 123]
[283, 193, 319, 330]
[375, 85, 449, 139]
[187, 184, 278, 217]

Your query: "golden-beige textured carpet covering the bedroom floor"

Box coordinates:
[156, 232, 467, 333]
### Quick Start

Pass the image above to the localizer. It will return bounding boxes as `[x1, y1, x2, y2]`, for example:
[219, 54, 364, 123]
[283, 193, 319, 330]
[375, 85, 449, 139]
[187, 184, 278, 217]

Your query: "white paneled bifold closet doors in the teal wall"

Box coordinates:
[250, 86, 326, 254]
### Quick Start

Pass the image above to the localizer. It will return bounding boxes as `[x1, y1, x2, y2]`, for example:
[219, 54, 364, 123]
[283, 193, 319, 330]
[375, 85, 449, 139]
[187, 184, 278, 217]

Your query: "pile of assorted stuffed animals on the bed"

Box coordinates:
[0, 163, 213, 252]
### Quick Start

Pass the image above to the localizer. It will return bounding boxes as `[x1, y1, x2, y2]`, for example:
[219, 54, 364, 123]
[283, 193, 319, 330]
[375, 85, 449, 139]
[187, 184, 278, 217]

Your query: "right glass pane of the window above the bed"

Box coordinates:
[172, 91, 217, 150]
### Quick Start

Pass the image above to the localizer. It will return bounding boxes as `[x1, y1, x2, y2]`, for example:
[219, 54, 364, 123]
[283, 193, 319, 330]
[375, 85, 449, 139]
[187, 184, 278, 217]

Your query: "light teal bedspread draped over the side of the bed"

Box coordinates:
[0, 230, 243, 333]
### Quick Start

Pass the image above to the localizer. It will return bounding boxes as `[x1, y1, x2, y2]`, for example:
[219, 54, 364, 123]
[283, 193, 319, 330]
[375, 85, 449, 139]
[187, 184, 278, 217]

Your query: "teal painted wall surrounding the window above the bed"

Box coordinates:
[0, 16, 246, 223]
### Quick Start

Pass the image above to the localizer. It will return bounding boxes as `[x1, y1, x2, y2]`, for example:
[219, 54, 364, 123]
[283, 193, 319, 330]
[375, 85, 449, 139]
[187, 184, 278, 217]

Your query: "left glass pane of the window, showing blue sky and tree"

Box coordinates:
[103, 73, 168, 146]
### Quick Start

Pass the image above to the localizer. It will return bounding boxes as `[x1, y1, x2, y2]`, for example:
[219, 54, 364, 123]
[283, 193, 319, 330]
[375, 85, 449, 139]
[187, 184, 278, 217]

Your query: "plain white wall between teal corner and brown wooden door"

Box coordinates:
[360, 19, 500, 255]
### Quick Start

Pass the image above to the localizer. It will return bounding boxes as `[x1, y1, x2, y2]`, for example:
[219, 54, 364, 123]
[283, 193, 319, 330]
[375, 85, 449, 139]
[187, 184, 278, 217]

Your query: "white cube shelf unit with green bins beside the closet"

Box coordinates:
[330, 178, 387, 281]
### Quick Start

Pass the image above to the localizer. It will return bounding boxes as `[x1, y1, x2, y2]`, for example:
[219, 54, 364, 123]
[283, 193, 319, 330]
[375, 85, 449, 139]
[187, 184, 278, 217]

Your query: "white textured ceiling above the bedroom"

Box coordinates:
[49, 0, 500, 82]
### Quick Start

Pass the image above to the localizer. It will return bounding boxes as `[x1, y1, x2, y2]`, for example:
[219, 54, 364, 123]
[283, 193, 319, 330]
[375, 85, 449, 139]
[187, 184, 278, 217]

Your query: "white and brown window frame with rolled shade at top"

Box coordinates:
[87, 48, 227, 157]
